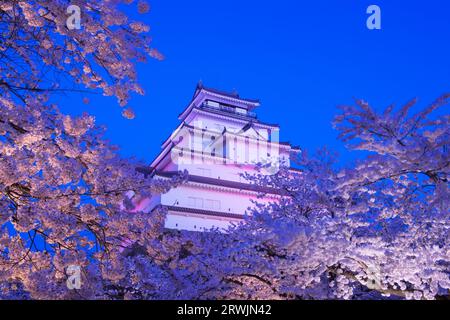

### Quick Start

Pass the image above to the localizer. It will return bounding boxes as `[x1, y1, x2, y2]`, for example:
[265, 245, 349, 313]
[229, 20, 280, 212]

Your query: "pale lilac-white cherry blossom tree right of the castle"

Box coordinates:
[201, 95, 450, 299]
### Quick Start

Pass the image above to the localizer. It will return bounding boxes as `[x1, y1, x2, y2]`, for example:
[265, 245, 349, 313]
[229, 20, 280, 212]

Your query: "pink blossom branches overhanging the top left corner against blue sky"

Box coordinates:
[0, 0, 162, 118]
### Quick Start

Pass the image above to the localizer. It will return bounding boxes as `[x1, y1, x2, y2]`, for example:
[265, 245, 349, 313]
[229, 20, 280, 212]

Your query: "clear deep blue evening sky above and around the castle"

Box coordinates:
[57, 0, 450, 163]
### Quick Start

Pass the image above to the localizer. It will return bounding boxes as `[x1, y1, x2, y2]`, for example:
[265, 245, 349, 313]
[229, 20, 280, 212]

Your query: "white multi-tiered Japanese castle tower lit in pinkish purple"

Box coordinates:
[146, 84, 300, 231]
